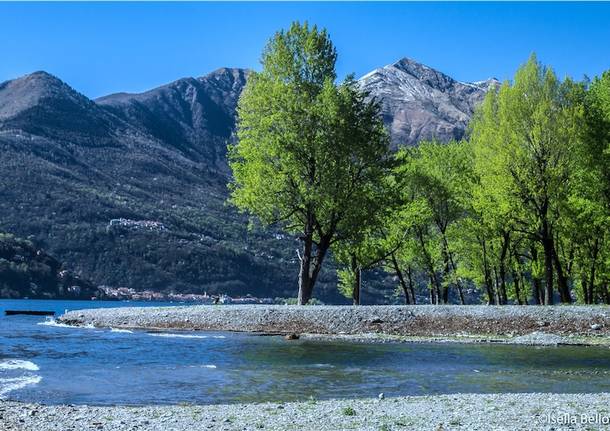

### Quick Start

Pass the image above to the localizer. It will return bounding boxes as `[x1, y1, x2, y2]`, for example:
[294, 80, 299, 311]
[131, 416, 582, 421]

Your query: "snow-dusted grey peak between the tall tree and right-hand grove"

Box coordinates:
[359, 58, 499, 147]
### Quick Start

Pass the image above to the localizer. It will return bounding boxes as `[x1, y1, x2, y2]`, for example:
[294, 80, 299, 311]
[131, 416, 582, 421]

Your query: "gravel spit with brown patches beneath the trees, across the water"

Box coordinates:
[58, 305, 610, 345]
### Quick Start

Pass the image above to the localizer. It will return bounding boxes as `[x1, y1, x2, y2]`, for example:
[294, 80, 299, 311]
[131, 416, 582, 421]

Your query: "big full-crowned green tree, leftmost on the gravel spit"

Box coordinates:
[229, 23, 390, 304]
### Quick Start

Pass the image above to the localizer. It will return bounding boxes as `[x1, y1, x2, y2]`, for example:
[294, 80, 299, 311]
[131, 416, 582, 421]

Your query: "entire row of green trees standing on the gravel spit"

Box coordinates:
[230, 23, 610, 304]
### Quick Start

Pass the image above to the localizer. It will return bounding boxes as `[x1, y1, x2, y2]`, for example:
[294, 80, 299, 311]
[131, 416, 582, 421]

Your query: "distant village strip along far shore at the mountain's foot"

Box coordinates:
[99, 286, 275, 304]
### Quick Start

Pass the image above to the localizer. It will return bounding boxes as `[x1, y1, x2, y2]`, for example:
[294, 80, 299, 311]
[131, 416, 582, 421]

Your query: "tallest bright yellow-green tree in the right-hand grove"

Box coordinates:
[472, 55, 578, 304]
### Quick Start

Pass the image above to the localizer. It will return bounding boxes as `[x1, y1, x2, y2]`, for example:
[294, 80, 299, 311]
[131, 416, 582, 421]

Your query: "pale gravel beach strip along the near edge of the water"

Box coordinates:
[0, 393, 610, 431]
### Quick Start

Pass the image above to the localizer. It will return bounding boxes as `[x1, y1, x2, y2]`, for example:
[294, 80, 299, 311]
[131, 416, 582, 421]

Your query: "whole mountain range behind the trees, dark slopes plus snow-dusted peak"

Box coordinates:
[0, 59, 497, 300]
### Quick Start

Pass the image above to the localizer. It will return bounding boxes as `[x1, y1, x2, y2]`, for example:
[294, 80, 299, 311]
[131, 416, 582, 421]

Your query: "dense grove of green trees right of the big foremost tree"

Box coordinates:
[364, 55, 610, 304]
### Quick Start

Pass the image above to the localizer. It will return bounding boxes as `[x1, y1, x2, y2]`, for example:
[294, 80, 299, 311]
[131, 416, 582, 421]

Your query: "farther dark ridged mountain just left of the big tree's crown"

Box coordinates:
[96, 68, 247, 169]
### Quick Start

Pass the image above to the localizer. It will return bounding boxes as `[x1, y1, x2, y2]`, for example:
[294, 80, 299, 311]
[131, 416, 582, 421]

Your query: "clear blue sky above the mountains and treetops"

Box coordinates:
[0, 3, 610, 97]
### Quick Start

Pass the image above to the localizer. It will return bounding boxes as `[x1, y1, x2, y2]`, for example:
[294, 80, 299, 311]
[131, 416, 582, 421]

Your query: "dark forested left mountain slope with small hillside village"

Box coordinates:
[0, 69, 334, 302]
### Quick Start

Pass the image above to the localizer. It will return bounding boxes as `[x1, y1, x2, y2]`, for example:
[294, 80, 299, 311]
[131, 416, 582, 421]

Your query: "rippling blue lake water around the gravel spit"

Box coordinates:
[0, 300, 610, 405]
